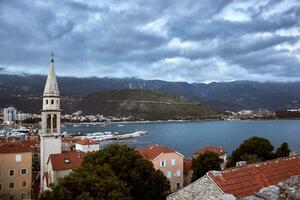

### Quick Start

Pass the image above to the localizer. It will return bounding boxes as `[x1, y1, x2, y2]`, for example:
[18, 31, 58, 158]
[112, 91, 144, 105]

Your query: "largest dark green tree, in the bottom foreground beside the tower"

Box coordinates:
[40, 145, 170, 200]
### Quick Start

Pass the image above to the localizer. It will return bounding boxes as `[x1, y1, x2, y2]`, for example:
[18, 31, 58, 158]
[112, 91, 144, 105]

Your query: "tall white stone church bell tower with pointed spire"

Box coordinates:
[40, 53, 61, 191]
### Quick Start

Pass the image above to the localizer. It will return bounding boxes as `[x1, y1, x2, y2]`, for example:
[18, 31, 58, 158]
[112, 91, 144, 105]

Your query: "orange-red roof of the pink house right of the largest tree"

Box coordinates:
[137, 145, 180, 160]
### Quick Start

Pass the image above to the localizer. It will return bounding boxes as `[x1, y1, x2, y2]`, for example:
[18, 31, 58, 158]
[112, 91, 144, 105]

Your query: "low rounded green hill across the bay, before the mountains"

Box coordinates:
[77, 90, 216, 120]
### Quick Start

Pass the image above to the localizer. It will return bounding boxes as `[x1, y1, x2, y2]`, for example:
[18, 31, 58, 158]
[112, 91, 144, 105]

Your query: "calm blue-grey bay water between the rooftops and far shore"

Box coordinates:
[62, 120, 300, 156]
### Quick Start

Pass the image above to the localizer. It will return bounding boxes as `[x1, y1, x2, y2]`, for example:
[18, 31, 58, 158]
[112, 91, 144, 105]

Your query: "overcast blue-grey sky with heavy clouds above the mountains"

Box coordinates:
[0, 0, 300, 83]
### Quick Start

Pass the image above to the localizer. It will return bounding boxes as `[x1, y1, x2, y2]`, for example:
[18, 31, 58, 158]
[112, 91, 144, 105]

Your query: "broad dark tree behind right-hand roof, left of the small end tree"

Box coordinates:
[226, 137, 274, 167]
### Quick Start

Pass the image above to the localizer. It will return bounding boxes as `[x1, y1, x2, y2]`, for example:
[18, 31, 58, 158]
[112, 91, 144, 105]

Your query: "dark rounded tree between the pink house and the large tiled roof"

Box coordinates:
[192, 152, 223, 181]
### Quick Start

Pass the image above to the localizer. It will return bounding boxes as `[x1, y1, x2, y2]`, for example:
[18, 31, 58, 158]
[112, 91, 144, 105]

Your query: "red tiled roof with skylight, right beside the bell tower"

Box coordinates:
[48, 151, 86, 170]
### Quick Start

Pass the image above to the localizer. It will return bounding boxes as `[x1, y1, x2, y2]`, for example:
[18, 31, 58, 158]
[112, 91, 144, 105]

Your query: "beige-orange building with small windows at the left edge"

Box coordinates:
[0, 142, 32, 200]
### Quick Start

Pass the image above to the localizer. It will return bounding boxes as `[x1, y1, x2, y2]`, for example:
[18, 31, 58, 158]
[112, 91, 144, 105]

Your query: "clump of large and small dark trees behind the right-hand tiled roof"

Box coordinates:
[226, 137, 290, 167]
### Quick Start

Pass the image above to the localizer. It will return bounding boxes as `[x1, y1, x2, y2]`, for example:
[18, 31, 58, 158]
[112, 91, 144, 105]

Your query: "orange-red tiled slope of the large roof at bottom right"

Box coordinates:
[208, 156, 300, 198]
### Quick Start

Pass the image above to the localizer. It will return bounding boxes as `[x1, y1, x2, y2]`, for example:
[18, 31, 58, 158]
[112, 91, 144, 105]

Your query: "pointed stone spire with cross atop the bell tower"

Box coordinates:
[44, 52, 59, 96]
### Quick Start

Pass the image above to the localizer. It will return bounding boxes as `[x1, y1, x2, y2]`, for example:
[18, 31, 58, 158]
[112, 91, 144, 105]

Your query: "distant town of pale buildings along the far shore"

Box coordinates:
[4, 106, 300, 125]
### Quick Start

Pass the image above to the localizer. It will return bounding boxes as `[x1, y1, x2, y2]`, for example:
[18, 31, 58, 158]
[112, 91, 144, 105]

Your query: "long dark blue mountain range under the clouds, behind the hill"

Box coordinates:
[0, 74, 300, 112]
